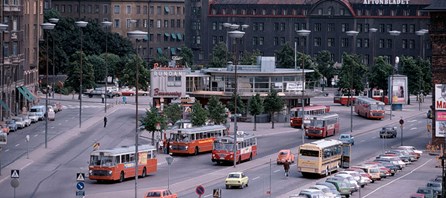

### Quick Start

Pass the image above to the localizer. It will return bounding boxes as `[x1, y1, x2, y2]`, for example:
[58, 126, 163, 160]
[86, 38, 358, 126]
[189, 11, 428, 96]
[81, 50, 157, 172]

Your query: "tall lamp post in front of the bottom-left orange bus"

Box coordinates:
[127, 30, 148, 198]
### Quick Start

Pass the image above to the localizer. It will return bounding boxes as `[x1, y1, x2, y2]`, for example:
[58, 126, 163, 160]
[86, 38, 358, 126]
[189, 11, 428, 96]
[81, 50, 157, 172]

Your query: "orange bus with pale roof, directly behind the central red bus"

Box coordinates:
[168, 125, 227, 155]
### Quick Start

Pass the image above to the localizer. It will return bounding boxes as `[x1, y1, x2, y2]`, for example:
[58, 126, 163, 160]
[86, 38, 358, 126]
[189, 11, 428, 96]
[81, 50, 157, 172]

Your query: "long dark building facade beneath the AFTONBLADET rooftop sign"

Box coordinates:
[185, 0, 431, 65]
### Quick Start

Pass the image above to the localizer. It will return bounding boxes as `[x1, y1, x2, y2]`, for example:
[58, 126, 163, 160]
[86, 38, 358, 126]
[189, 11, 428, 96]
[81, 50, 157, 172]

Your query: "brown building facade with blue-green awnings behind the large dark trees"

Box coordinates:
[51, 0, 185, 60]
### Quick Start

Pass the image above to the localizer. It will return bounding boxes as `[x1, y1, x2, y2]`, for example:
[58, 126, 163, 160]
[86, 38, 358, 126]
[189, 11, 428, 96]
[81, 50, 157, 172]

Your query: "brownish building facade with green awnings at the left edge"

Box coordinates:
[0, 0, 43, 121]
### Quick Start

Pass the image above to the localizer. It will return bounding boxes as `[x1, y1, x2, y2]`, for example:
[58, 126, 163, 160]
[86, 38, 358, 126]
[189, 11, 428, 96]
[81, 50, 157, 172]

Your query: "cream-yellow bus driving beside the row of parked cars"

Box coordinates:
[297, 139, 342, 176]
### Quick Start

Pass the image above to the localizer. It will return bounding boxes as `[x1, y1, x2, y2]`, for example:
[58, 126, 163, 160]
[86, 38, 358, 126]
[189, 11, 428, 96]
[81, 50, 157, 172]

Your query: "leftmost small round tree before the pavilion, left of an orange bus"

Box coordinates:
[139, 107, 167, 145]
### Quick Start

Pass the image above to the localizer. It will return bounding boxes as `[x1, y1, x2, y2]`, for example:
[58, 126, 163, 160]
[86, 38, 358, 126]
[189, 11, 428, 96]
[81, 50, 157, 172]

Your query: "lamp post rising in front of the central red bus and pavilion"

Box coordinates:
[228, 30, 245, 168]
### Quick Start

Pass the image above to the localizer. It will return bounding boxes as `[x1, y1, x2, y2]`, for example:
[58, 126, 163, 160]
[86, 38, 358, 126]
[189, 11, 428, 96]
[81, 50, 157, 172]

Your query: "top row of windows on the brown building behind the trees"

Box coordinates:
[54, 4, 185, 15]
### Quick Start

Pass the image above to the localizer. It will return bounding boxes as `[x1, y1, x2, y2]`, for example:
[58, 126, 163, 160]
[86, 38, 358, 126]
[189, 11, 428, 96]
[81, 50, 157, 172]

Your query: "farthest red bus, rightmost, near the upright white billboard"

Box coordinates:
[355, 96, 385, 119]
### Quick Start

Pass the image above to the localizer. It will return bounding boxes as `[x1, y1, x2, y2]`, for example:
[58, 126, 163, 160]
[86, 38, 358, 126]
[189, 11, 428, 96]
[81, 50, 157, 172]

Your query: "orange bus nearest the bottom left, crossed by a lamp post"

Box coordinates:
[88, 145, 157, 182]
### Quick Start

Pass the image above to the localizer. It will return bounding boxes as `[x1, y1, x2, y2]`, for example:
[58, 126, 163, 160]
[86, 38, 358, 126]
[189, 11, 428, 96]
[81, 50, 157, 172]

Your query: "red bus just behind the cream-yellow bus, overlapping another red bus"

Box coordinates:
[305, 113, 339, 138]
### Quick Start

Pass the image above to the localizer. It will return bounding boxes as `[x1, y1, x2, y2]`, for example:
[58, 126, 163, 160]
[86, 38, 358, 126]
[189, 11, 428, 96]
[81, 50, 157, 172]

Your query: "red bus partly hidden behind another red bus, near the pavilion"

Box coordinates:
[290, 105, 330, 128]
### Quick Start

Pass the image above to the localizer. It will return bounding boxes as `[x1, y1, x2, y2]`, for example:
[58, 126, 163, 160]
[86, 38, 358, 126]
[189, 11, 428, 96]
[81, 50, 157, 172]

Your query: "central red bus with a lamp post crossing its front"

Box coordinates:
[212, 131, 257, 164]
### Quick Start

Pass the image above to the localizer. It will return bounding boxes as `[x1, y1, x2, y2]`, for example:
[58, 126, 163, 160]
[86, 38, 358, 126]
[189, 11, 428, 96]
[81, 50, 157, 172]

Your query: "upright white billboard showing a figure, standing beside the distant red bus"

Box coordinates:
[389, 75, 408, 104]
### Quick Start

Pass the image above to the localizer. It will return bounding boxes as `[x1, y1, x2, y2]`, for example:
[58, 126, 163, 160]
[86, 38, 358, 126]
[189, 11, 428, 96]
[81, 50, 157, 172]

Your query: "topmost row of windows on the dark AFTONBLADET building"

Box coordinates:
[211, 6, 427, 16]
